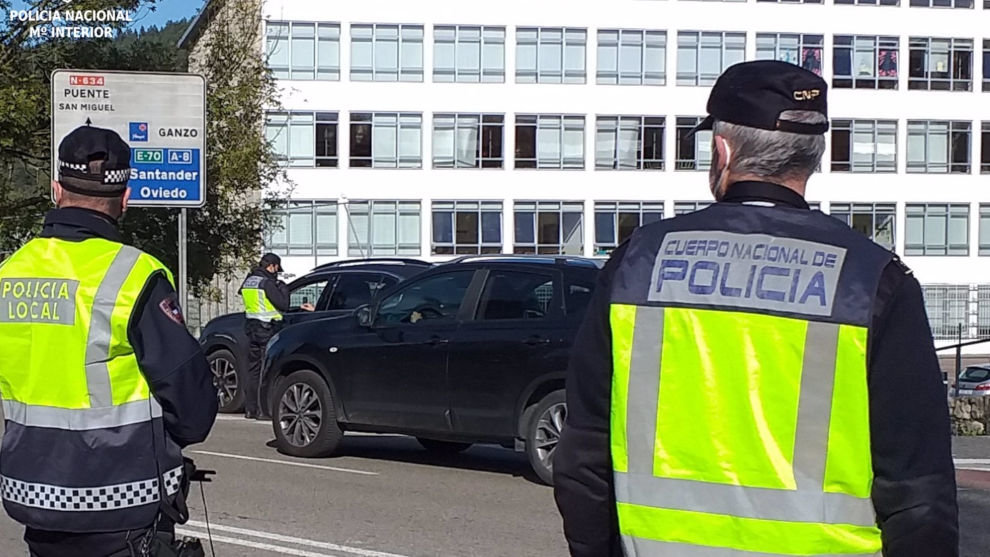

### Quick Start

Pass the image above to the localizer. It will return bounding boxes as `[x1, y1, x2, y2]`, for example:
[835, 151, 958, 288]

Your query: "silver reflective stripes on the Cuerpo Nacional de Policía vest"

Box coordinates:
[615, 314, 876, 557]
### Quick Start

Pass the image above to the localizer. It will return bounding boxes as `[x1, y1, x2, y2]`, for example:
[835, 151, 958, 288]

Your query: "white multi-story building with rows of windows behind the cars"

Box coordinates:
[190, 0, 990, 346]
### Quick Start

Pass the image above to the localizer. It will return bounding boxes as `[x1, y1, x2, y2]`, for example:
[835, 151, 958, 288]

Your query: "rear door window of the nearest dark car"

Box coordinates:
[478, 271, 554, 321]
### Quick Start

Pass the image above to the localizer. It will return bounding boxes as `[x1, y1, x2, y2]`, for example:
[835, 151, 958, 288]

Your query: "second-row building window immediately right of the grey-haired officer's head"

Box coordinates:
[832, 120, 897, 172]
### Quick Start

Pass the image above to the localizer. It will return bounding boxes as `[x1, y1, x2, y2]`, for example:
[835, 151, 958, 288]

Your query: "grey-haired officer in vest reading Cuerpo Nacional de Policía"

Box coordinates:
[554, 61, 959, 557]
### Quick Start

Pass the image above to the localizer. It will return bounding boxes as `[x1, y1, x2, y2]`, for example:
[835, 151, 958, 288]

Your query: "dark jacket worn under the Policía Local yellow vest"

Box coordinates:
[24, 208, 217, 557]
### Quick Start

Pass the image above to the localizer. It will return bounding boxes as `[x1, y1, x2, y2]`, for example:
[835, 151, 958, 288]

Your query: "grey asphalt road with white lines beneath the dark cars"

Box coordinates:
[0, 417, 990, 557]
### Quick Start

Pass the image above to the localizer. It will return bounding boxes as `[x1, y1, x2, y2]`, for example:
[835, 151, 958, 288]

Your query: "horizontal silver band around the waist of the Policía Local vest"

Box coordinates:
[3, 397, 162, 431]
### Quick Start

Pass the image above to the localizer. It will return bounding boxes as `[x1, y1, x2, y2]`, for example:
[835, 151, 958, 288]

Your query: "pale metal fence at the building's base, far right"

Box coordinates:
[922, 284, 990, 340]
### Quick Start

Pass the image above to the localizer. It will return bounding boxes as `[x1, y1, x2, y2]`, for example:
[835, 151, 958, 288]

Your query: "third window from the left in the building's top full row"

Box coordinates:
[433, 25, 505, 83]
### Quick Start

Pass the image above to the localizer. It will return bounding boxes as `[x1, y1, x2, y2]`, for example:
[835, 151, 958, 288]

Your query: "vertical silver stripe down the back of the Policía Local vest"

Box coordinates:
[86, 246, 141, 408]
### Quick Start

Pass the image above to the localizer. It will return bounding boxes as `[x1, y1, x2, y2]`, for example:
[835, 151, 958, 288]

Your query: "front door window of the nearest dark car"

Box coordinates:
[375, 270, 474, 325]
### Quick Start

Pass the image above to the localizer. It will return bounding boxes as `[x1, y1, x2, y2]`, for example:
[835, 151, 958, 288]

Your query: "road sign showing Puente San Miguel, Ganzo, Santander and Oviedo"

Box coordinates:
[52, 70, 206, 207]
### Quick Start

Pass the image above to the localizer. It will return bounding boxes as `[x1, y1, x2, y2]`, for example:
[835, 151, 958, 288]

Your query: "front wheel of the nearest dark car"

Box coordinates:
[272, 369, 344, 458]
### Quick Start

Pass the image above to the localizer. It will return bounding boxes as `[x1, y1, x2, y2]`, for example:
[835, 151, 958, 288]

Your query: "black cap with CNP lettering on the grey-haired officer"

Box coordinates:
[692, 60, 828, 135]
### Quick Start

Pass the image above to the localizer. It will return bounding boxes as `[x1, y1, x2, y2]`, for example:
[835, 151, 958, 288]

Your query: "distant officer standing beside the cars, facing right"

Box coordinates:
[240, 253, 314, 420]
